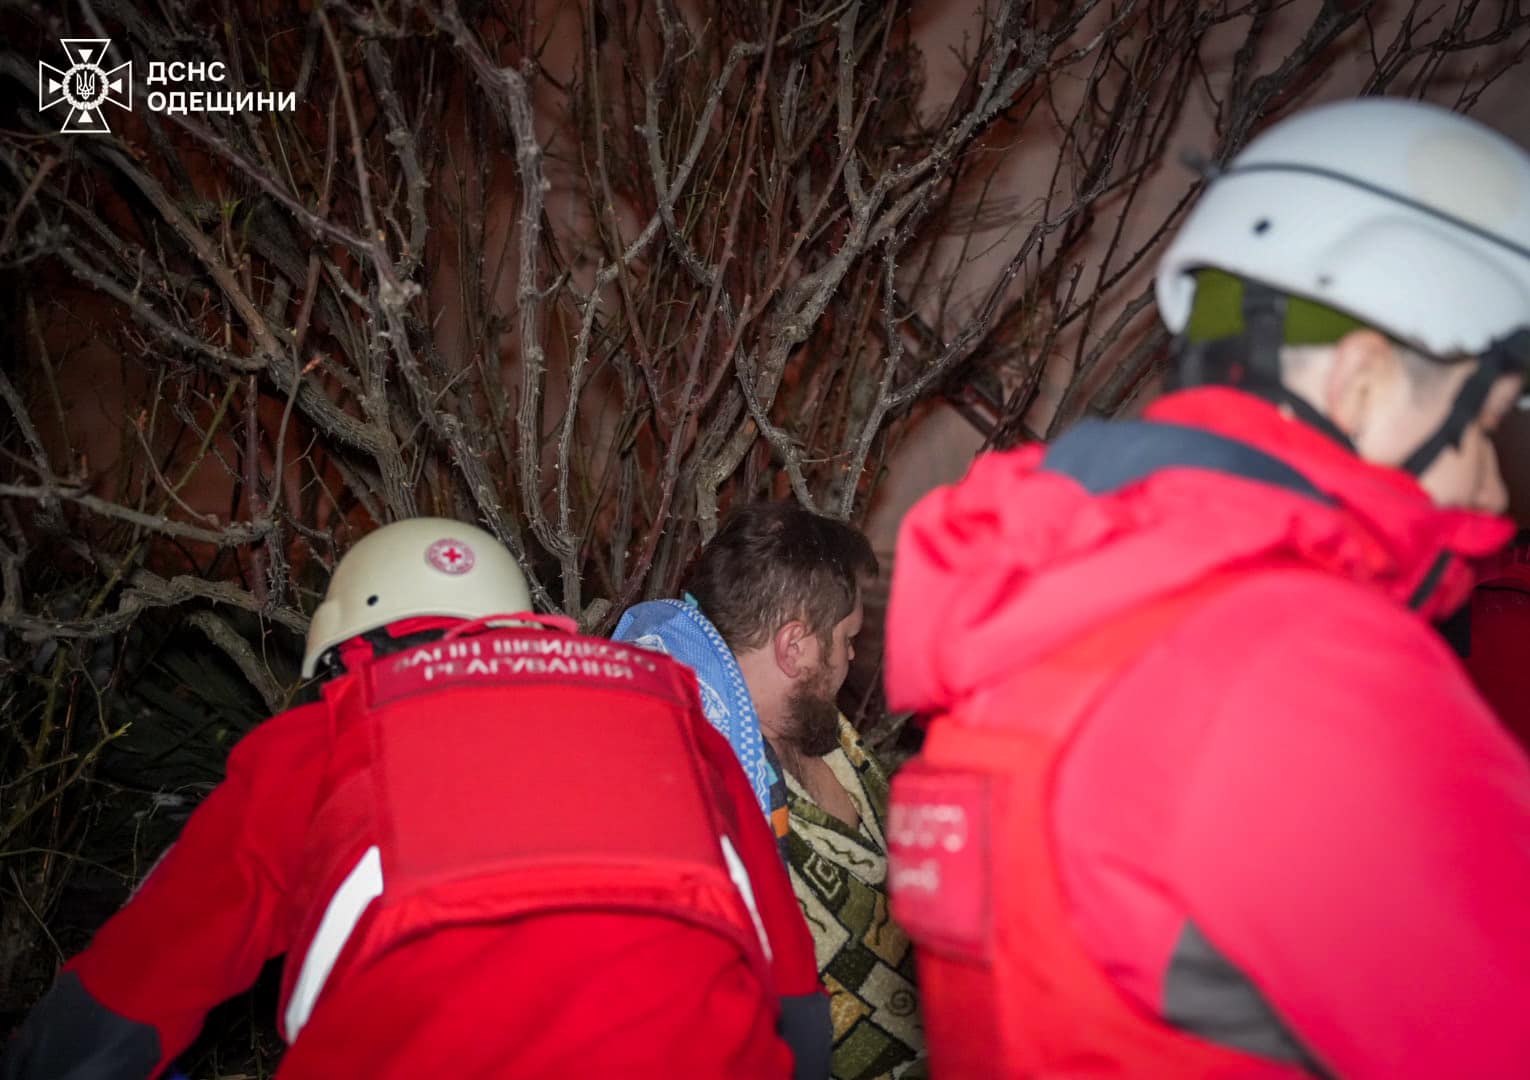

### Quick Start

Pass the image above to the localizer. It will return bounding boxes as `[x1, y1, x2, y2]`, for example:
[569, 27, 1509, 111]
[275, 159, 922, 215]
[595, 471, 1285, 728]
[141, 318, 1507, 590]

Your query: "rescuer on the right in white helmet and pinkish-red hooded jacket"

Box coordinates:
[886, 99, 1530, 1080]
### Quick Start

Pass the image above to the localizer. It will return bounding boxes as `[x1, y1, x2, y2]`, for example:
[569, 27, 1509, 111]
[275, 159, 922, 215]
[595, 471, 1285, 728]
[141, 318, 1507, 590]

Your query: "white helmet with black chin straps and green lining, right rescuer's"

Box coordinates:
[1157, 98, 1530, 476]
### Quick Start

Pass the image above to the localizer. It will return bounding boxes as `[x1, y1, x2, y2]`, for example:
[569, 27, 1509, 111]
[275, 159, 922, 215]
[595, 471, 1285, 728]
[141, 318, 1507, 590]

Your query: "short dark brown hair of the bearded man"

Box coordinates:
[682, 502, 877, 652]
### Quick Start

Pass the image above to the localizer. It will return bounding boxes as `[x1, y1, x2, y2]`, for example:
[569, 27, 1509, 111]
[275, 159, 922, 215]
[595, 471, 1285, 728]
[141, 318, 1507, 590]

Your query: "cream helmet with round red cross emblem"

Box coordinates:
[303, 517, 531, 678]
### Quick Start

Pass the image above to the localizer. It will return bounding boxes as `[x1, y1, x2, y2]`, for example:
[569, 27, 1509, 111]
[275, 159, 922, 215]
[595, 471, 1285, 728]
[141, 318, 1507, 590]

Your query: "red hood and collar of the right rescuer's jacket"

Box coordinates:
[886, 387, 1513, 713]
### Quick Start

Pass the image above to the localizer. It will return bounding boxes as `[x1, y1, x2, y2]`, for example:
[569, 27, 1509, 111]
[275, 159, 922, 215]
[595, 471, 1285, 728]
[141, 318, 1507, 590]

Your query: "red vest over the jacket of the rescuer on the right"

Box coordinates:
[887, 574, 1307, 1080]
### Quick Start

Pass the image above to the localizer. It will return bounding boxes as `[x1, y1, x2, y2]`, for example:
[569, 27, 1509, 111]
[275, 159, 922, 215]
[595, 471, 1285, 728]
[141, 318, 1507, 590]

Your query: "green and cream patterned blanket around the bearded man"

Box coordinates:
[767, 717, 926, 1080]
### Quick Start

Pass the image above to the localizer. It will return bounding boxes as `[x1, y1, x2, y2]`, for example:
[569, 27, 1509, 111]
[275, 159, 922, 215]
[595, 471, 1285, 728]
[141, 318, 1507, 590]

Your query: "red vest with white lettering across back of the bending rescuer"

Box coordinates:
[282, 627, 774, 1040]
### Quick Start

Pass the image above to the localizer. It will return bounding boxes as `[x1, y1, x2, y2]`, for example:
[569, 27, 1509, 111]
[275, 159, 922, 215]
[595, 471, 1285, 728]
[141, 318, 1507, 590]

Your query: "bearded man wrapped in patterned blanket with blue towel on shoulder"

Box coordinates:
[617, 503, 924, 1080]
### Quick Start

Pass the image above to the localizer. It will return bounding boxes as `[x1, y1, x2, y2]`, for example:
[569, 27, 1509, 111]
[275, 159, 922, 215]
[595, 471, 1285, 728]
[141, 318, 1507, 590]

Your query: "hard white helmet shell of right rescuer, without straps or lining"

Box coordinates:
[1157, 98, 1530, 358]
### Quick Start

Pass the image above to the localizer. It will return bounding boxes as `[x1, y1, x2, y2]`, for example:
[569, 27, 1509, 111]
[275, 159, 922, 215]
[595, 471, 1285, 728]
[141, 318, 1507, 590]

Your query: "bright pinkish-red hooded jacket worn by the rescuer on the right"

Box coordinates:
[887, 389, 1530, 1080]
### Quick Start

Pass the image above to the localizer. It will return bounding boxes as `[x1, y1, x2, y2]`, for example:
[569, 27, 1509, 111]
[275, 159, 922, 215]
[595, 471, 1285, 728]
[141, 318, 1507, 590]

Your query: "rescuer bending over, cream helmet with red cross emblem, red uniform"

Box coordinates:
[0, 519, 831, 1080]
